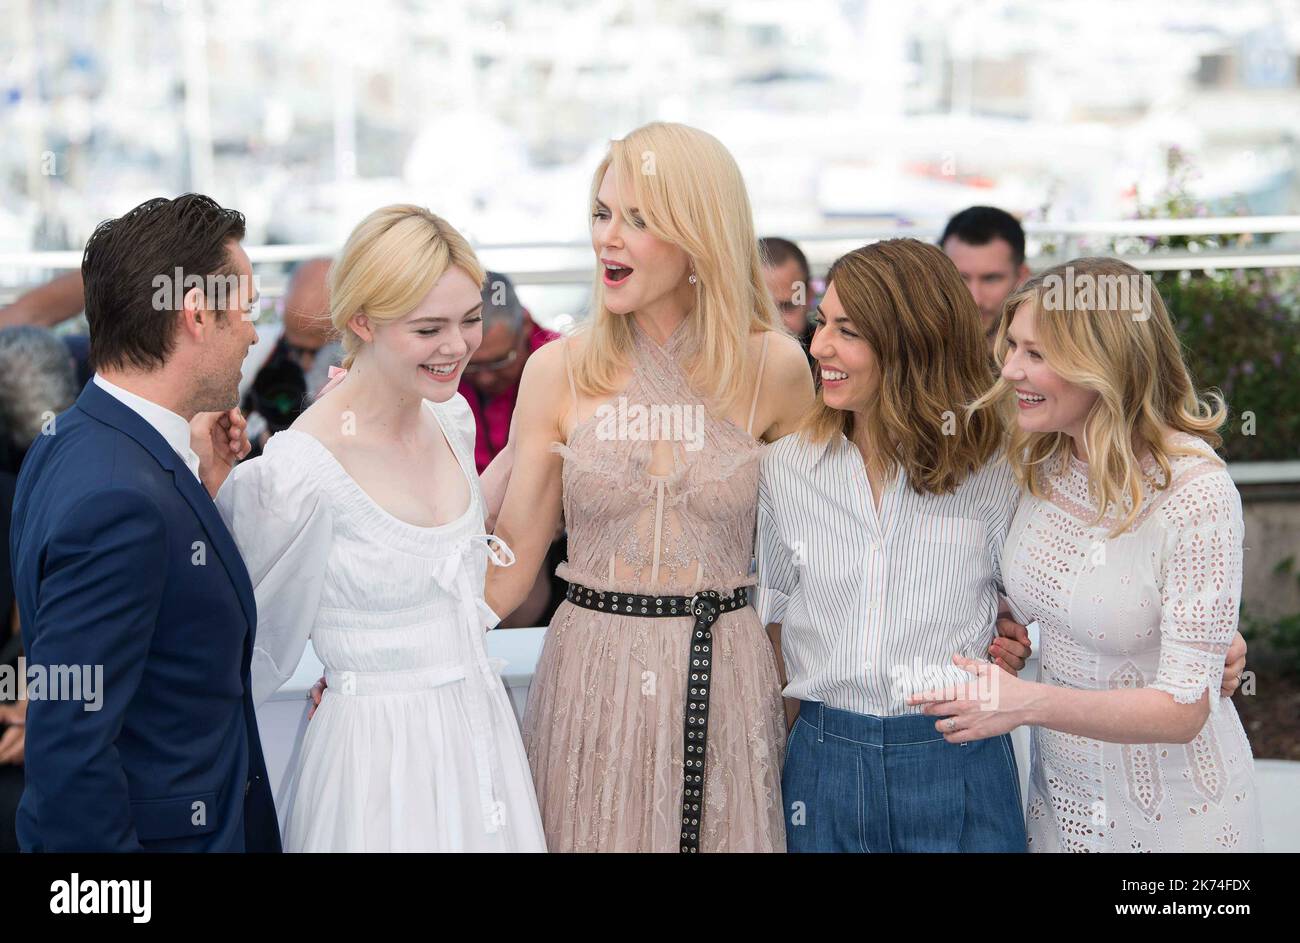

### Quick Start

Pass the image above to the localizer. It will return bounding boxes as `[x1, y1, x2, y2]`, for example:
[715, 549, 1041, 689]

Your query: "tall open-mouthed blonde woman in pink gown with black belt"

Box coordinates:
[486, 124, 813, 853]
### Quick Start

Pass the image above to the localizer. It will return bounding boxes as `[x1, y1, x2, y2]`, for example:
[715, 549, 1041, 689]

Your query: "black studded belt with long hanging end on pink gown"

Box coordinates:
[567, 583, 749, 855]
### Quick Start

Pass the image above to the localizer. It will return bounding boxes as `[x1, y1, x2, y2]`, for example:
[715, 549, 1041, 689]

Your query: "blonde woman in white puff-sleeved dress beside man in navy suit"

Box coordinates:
[217, 206, 545, 851]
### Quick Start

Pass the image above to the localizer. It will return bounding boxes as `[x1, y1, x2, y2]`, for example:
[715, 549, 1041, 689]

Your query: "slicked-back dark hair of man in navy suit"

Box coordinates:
[82, 194, 244, 369]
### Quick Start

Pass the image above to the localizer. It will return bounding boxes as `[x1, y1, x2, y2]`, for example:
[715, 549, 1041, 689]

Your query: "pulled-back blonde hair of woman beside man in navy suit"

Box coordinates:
[329, 203, 486, 369]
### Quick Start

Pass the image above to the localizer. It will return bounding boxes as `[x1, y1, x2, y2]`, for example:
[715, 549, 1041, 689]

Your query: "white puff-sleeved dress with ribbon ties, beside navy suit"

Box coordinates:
[217, 394, 546, 852]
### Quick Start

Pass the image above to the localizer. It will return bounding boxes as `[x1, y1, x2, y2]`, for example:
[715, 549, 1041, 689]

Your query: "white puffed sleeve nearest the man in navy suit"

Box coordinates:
[217, 440, 334, 705]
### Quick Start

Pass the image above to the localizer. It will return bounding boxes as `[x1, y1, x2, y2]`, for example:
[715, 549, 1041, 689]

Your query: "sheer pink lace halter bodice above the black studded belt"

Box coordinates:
[553, 323, 767, 594]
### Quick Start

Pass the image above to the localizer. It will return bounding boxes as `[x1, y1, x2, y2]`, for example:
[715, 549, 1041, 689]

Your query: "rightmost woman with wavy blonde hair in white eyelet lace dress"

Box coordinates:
[914, 259, 1260, 852]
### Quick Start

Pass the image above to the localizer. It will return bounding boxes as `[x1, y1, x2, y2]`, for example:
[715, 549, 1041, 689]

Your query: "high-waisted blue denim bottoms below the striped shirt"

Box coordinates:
[781, 701, 1024, 852]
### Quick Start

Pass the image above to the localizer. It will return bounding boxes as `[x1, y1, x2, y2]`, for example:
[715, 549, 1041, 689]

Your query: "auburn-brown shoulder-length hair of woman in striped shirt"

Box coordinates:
[798, 239, 1002, 494]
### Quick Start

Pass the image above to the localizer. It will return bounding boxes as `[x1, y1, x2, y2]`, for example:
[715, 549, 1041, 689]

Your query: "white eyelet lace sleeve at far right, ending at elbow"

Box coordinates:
[1151, 468, 1244, 711]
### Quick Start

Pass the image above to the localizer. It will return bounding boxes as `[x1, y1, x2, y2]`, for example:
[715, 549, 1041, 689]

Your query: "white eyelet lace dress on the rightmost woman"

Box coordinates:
[1002, 436, 1260, 852]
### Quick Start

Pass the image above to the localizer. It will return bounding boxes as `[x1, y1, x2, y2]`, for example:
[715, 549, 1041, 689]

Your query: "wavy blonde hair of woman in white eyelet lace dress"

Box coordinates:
[970, 258, 1227, 537]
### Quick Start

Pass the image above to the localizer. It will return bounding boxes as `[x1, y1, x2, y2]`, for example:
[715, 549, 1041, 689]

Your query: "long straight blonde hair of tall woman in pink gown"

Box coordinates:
[573, 122, 777, 410]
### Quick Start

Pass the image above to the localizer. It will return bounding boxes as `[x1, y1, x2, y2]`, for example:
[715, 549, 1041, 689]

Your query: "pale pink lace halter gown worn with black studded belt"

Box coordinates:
[524, 328, 785, 852]
